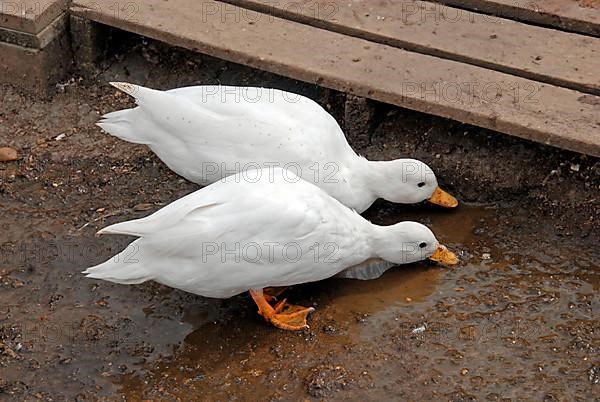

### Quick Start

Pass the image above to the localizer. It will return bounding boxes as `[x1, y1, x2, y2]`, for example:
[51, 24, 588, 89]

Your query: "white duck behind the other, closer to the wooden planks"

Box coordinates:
[98, 82, 458, 212]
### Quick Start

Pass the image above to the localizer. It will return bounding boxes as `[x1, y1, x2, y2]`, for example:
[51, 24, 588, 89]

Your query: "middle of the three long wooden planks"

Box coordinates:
[224, 0, 600, 95]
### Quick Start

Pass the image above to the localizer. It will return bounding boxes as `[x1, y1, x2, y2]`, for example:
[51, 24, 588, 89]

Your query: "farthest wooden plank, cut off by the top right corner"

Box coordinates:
[436, 0, 600, 37]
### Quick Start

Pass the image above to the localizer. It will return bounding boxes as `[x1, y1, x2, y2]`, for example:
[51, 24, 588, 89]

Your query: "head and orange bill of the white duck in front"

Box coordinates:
[373, 221, 458, 265]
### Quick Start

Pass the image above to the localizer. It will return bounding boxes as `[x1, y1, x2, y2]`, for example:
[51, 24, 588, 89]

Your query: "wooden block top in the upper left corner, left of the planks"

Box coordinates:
[0, 0, 67, 35]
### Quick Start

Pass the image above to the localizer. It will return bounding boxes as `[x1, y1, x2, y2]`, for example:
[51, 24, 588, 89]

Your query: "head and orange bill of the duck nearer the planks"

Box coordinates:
[369, 159, 458, 208]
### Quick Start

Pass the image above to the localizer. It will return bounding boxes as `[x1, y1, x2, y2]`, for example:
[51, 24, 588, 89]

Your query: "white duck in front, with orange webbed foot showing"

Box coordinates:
[84, 168, 457, 330]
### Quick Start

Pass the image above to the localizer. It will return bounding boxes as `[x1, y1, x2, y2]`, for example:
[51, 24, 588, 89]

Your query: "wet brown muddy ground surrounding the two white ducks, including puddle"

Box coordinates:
[0, 33, 600, 401]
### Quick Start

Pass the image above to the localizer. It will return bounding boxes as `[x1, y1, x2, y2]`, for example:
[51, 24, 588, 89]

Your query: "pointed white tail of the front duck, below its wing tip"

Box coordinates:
[83, 242, 153, 285]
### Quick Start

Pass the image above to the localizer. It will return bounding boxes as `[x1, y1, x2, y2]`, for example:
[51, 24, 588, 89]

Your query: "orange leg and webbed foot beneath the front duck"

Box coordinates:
[249, 289, 315, 331]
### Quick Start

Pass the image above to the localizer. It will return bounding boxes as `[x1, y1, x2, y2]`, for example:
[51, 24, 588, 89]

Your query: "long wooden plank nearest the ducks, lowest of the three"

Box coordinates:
[72, 0, 600, 156]
